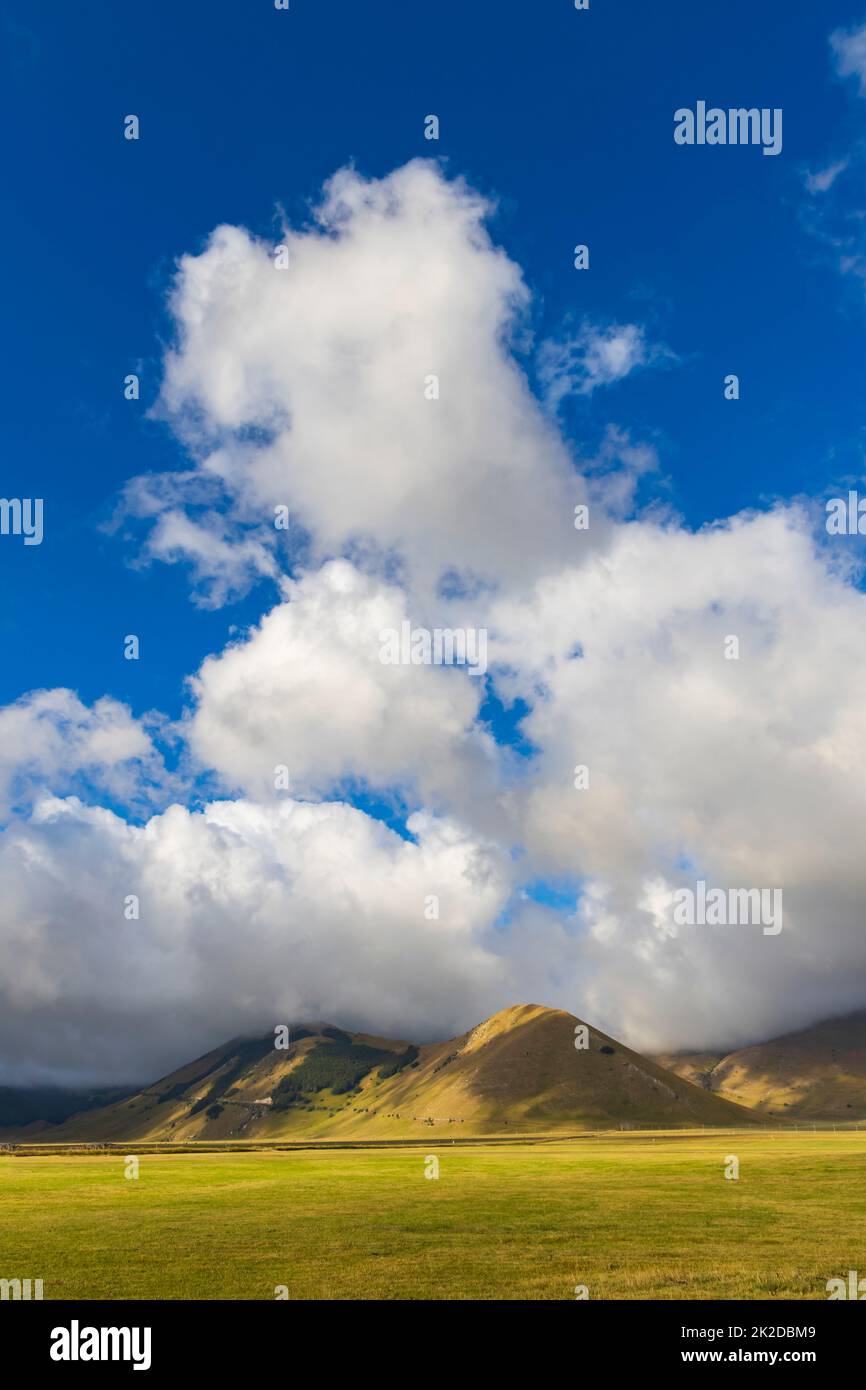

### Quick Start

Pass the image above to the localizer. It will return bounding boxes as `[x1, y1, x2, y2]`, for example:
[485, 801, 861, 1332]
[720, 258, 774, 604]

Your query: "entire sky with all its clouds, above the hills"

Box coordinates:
[8, 0, 866, 1081]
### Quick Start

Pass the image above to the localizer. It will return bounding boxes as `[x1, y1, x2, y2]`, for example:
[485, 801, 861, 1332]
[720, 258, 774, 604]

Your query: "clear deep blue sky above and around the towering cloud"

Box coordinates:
[0, 0, 863, 714]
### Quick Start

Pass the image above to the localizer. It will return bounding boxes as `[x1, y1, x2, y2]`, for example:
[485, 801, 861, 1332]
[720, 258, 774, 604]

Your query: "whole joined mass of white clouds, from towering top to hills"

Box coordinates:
[0, 154, 866, 1080]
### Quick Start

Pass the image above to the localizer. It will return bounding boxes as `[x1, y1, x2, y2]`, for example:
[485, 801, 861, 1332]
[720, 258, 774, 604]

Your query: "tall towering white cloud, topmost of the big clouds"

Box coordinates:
[135, 161, 600, 594]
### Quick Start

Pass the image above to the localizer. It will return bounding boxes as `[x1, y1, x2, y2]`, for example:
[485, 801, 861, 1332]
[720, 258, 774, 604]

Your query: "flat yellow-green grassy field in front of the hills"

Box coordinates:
[0, 1131, 866, 1300]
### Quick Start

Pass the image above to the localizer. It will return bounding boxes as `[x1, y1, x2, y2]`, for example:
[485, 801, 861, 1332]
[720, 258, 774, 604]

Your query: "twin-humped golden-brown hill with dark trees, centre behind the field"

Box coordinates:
[5, 1004, 751, 1143]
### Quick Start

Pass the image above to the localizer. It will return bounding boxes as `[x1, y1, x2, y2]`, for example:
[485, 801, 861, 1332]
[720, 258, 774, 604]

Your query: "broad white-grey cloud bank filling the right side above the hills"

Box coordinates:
[483, 509, 866, 1045]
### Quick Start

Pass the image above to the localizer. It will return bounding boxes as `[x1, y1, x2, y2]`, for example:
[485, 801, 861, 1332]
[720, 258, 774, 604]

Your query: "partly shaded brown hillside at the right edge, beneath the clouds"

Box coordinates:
[656, 1011, 866, 1120]
